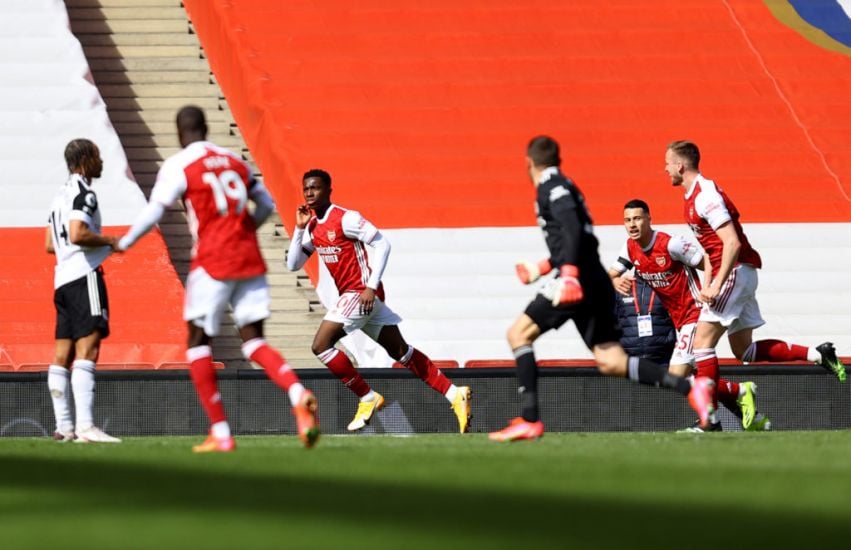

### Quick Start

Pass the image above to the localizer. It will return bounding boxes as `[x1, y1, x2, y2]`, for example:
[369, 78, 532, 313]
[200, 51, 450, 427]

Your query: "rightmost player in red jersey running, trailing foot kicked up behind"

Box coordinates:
[665, 141, 846, 430]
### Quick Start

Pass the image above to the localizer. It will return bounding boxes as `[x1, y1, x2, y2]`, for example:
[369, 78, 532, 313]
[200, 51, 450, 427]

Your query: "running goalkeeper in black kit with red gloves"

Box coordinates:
[490, 136, 711, 441]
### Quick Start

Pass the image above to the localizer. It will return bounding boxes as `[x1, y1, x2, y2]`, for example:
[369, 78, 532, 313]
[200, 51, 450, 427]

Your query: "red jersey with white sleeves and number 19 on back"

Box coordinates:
[151, 141, 266, 280]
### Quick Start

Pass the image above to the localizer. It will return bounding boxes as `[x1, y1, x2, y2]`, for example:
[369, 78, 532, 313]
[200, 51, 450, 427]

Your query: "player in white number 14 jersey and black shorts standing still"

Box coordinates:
[45, 139, 121, 443]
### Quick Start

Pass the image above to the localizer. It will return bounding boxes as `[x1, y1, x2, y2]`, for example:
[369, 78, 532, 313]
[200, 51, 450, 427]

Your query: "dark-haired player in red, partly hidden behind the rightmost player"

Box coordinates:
[609, 199, 770, 432]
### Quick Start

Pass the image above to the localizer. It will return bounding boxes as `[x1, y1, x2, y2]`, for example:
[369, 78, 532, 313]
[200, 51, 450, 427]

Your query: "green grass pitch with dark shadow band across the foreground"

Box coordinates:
[0, 431, 851, 550]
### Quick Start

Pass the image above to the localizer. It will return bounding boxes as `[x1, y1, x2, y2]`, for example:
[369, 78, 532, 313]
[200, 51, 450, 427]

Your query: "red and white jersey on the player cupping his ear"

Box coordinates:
[302, 204, 384, 300]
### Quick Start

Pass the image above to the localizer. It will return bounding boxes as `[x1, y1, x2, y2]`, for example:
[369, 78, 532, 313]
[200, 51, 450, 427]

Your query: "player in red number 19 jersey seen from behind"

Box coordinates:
[119, 106, 319, 453]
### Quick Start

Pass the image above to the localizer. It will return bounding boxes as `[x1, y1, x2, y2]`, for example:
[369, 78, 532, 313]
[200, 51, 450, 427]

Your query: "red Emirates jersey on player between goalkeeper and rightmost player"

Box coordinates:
[618, 231, 703, 330]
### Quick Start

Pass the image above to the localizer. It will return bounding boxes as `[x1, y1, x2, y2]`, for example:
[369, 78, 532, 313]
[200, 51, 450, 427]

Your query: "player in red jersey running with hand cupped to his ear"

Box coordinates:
[287, 170, 471, 433]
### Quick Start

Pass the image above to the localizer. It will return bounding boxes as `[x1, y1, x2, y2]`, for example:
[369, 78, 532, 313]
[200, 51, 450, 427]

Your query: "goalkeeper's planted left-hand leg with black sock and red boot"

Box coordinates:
[488, 313, 544, 441]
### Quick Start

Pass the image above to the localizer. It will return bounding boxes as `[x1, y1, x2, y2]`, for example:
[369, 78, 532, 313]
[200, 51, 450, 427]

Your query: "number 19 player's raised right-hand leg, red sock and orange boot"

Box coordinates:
[239, 319, 319, 448]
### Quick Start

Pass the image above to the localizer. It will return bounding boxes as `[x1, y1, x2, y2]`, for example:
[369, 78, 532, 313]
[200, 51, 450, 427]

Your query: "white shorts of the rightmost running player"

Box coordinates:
[699, 264, 765, 335]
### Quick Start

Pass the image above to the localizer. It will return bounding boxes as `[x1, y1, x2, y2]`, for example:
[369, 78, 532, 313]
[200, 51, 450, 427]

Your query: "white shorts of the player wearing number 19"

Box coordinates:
[183, 267, 270, 336]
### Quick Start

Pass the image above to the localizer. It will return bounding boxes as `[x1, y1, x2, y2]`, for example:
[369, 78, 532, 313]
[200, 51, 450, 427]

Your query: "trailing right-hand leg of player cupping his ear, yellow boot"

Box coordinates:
[377, 325, 472, 433]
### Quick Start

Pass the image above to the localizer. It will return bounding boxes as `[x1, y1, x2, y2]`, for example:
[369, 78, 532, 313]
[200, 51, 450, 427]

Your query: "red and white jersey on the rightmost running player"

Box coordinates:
[684, 175, 762, 275]
